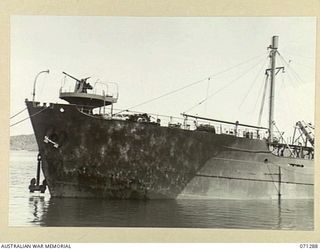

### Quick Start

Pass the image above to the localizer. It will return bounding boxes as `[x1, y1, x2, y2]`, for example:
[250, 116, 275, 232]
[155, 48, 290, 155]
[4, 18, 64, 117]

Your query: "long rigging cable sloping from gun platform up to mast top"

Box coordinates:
[115, 53, 264, 115]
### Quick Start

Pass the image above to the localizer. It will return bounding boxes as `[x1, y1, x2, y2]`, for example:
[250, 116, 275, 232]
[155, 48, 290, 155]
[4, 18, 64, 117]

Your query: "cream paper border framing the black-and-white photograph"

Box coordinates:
[0, 0, 320, 243]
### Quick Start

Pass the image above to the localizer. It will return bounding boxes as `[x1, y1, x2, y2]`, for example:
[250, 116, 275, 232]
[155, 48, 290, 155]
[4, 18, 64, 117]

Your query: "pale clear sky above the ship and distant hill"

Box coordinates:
[10, 16, 316, 139]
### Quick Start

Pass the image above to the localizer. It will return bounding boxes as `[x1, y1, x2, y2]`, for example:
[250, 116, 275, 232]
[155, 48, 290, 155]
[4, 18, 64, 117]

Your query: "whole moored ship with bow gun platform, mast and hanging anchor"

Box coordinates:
[25, 36, 314, 200]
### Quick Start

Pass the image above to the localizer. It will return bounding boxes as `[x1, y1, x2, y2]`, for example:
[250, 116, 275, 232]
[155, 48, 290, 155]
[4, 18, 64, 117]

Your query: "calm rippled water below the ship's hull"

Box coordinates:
[9, 151, 314, 230]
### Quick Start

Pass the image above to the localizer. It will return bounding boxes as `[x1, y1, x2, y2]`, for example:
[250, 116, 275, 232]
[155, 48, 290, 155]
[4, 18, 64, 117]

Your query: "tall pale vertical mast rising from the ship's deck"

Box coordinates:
[269, 36, 279, 144]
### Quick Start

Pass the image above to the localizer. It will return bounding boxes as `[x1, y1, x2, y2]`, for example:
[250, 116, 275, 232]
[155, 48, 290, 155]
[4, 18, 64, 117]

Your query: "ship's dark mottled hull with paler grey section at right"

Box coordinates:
[26, 101, 314, 199]
